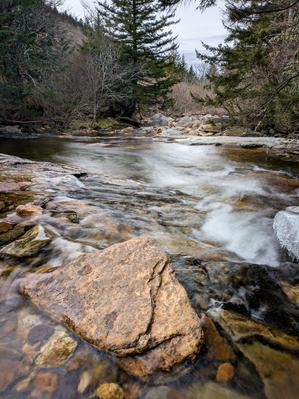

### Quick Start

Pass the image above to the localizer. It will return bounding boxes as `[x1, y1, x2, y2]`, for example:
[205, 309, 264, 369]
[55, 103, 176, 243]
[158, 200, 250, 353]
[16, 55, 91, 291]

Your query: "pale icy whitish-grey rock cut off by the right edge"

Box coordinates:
[273, 206, 299, 260]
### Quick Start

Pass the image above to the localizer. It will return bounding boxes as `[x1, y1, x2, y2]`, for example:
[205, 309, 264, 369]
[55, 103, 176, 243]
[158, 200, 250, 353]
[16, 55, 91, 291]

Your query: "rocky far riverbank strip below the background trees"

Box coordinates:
[0, 113, 297, 144]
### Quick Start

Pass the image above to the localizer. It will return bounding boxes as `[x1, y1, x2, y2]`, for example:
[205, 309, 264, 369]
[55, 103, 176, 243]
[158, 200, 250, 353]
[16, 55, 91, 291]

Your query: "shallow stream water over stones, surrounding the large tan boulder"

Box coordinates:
[0, 138, 299, 399]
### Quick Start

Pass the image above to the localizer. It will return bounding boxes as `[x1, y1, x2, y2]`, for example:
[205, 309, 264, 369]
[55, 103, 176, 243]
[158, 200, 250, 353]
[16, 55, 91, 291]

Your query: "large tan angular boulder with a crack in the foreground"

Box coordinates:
[21, 238, 203, 377]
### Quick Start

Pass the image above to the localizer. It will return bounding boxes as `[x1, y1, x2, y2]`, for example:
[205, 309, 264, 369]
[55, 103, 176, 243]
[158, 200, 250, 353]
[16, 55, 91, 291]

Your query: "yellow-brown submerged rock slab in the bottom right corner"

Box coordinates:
[216, 310, 299, 399]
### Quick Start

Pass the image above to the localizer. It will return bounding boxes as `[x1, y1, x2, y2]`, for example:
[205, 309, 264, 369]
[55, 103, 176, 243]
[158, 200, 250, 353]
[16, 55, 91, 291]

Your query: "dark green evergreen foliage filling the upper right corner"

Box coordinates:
[198, 0, 299, 132]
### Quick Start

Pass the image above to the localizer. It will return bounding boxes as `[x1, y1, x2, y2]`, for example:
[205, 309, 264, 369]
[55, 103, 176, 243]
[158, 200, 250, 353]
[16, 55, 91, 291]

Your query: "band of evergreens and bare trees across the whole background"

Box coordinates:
[0, 0, 299, 135]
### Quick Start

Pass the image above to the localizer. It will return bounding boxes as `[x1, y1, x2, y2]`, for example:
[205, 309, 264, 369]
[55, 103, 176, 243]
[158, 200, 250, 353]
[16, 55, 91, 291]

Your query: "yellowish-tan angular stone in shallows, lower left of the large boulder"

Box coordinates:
[35, 328, 77, 367]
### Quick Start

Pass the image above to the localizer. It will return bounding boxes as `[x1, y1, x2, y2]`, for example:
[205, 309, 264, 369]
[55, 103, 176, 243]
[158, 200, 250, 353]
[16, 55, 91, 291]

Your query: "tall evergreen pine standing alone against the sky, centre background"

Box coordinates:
[98, 0, 177, 112]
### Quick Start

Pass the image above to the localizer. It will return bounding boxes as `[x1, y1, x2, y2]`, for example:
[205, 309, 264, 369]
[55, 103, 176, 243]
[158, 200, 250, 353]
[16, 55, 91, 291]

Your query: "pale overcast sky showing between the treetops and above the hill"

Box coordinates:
[64, 0, 226, 63]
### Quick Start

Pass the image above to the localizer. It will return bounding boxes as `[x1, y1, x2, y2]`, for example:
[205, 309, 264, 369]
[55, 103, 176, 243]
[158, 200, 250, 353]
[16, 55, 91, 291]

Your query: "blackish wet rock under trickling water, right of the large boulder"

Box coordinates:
[176, 258, 299, 335]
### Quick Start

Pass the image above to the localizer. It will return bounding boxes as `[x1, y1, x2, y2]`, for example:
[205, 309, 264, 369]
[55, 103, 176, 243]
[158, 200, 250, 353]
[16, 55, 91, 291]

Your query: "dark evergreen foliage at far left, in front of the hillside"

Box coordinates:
[0, 0, 67, 120]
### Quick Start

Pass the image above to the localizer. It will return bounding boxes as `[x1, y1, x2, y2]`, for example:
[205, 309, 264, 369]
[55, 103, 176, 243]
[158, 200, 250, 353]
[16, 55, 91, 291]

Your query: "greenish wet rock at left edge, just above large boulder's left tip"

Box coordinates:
[0, 225, 51, 258]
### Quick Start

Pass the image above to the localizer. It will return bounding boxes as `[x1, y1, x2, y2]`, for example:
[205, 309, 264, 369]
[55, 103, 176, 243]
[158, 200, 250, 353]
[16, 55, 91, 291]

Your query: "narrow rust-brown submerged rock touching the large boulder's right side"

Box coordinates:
[201, 315, 236, 362]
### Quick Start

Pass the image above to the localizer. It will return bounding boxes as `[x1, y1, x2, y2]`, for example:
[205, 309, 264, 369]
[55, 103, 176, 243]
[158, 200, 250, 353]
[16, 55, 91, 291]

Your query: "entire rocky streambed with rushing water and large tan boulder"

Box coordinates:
[0, 138, 299, 399]
